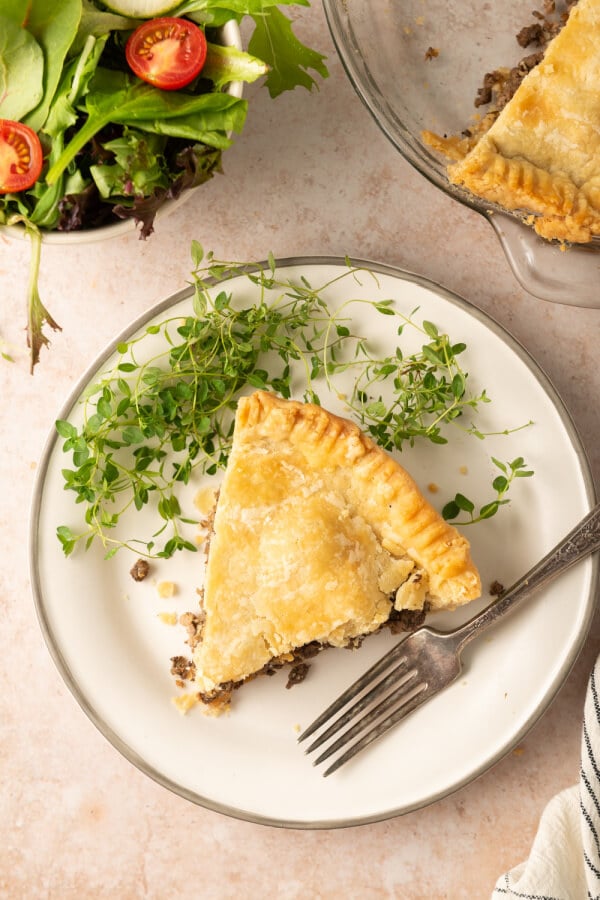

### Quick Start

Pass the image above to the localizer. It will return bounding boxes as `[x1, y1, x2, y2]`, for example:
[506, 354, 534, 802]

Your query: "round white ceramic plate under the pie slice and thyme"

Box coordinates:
[30, 258, 597, 828]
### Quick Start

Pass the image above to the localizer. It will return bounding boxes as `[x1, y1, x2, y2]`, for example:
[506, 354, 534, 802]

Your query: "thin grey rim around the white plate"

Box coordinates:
[28, 256, 599, 830]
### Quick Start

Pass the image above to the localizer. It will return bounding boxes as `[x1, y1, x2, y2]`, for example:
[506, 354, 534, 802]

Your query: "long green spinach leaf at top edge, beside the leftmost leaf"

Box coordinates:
[24, 0, 81, 131]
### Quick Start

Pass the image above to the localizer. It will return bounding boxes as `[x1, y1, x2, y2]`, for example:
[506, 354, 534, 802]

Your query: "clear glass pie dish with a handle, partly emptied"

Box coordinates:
[324, 0, 600, 308]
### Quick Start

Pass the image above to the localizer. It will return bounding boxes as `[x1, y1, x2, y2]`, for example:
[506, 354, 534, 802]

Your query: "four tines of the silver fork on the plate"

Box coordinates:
[298, 641, 428, 775]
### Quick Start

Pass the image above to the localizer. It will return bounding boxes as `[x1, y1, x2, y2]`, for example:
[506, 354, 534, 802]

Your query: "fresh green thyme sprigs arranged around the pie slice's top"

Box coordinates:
[56, 242, 536, 557]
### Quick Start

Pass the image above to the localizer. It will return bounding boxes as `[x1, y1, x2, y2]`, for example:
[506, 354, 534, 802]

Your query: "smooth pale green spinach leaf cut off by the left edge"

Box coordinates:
[0, 14, 44, 121]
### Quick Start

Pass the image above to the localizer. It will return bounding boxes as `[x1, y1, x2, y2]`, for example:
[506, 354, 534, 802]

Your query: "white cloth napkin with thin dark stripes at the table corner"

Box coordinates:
[492, 657, 600, 900]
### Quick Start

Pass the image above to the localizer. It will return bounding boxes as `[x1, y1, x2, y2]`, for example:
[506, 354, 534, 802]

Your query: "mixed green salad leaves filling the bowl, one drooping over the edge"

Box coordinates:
[0, 0, 328, 371]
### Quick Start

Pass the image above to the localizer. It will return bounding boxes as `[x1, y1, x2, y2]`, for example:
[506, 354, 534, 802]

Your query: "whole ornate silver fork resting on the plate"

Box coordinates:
[298, 504, 600, 775]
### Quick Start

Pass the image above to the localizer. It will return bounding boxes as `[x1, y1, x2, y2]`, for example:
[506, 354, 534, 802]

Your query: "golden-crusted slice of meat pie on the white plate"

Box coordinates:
[193, 391, 480, 703]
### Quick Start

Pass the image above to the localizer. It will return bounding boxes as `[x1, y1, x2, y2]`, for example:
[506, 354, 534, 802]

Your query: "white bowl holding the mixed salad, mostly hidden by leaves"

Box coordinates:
[0, 20, 244, 246]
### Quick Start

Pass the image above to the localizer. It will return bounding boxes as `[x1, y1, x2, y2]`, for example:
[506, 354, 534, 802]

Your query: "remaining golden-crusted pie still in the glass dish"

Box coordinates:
[423, 0, 600, 243]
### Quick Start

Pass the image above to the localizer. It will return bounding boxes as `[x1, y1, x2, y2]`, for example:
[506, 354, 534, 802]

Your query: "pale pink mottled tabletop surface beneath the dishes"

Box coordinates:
[0, 4, 600, 900]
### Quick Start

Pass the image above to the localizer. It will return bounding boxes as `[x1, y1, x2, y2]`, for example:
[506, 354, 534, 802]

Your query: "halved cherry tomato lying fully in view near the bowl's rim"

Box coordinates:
[125, 17, 207, 91]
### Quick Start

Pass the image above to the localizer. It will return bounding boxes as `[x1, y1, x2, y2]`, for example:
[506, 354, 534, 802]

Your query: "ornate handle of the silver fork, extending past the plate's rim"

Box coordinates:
[452, 504, 600, 652]
